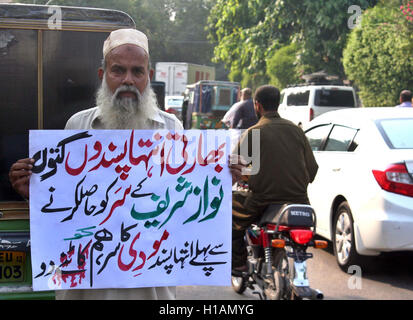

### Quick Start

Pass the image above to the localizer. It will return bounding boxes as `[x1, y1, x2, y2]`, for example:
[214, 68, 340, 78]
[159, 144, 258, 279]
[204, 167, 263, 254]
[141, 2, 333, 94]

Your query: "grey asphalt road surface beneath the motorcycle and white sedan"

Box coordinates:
[177, 242, 413, 300]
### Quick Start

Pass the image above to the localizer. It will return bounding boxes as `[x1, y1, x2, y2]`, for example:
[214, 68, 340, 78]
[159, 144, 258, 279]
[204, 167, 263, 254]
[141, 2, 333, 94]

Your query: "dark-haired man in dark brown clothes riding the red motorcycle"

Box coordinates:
[230, 85, 318, 272]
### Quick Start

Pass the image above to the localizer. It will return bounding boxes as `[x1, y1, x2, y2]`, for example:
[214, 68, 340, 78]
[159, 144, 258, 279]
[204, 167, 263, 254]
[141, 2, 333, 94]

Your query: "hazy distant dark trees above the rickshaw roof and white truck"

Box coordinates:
[15, 0, 217, 73]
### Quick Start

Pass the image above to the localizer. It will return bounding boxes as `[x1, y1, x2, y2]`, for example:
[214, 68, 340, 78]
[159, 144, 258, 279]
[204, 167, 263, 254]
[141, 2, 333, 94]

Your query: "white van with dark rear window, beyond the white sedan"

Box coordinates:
[278, 85, 358, 126]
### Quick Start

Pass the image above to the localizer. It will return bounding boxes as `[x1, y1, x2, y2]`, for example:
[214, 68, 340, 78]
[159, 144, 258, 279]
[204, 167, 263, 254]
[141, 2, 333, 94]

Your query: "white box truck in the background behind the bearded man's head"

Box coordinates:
[155, 62, 215, 96]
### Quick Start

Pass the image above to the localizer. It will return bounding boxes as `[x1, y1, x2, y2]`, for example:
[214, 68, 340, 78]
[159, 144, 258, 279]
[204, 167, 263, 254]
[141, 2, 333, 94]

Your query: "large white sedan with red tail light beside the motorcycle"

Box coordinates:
[305, 107, 413, 272]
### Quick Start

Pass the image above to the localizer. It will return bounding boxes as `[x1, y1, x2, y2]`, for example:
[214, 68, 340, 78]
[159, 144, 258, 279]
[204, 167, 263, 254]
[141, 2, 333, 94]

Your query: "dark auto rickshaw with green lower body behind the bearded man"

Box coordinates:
[0, 4, 135, 299]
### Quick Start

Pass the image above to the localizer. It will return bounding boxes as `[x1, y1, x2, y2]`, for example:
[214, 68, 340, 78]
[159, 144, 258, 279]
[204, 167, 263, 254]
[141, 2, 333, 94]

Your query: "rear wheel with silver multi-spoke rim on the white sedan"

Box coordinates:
[333, 201, 360, 272]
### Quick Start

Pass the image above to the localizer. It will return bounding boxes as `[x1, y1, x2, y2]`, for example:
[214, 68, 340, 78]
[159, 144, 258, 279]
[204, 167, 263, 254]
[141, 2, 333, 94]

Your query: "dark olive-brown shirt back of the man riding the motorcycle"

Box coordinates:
[248, 111, 317, 203]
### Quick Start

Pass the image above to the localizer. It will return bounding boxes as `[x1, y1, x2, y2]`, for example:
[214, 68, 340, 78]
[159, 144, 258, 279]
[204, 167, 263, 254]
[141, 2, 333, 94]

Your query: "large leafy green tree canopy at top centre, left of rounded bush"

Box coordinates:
[207, 0, 377, 87]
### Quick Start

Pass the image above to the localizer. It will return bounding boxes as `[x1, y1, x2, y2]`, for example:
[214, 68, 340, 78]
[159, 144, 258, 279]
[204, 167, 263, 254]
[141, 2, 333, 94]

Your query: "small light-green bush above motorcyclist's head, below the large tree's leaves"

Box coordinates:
[267, 43, 300, 90]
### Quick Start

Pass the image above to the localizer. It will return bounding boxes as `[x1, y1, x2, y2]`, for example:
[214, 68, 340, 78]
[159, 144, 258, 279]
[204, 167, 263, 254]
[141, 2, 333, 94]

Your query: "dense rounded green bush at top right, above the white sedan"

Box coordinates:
[343, 3, 413, 107]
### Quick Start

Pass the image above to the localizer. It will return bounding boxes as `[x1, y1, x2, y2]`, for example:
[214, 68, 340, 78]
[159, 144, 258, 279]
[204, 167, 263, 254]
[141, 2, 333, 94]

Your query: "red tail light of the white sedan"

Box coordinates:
[373, 163, 413, 197]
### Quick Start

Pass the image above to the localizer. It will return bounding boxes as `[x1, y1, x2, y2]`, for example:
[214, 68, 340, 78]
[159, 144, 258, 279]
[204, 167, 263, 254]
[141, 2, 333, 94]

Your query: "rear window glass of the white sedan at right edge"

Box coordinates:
[377, 118, 413, 149]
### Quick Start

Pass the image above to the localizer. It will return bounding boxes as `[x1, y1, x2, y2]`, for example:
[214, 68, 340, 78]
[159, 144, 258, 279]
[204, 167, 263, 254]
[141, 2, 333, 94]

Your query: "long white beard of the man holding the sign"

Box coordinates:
[96, 76, 158, 129]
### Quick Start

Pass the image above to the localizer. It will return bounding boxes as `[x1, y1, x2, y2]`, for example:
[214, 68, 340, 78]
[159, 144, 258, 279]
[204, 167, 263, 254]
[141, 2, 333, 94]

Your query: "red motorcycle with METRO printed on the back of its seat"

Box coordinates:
[232, 204, 327, 300]
